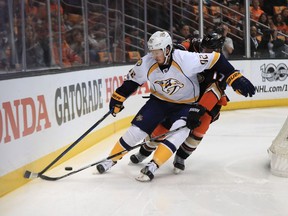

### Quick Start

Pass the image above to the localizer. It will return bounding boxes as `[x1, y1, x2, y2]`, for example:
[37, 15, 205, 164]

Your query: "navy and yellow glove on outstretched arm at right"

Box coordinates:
[226, 71, 255, 97]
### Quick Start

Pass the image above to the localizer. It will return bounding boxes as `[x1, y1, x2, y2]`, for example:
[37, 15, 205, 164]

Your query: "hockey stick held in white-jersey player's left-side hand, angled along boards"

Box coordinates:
[24, 110, 112, 179]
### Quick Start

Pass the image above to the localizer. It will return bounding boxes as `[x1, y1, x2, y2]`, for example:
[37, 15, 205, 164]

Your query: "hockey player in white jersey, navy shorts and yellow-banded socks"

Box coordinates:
[96, 31, 255, 181]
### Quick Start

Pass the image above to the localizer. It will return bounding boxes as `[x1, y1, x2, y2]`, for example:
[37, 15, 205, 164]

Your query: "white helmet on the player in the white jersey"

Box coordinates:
[148, 31, 173, 59]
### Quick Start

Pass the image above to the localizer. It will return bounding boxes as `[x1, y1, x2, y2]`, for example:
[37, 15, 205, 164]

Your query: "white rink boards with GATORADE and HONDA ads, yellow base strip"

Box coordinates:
[0, 60, 288, 196]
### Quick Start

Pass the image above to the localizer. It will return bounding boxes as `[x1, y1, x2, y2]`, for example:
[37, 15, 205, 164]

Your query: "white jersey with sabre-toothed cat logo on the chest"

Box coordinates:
[127, 50, 220, 104]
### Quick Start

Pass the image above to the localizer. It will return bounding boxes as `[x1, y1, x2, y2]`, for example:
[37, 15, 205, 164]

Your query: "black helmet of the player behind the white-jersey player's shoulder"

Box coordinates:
[201, 32, 225, 50]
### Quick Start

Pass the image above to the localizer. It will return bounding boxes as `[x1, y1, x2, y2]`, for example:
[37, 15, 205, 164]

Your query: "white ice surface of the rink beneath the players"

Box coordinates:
[0, 107, 288, 216]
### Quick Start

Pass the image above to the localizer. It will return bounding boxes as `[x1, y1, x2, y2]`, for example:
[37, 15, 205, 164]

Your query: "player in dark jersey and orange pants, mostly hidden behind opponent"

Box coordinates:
[130, 33, 231, 173]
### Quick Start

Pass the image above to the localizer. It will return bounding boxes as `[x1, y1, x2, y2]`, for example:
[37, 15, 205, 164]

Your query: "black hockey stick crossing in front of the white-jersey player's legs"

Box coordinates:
[38, 126, 186, 181]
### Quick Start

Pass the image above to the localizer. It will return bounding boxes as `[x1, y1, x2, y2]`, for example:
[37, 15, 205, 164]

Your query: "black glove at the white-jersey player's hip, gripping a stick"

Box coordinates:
[186, 104, 206, 130]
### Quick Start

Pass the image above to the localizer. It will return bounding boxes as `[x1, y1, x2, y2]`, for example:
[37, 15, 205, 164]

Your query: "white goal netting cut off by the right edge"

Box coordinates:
[268, 117, 288, 177]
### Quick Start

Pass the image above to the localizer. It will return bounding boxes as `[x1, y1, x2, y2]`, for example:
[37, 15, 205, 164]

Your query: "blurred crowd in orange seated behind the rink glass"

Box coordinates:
[0, 0, 288, 75]
